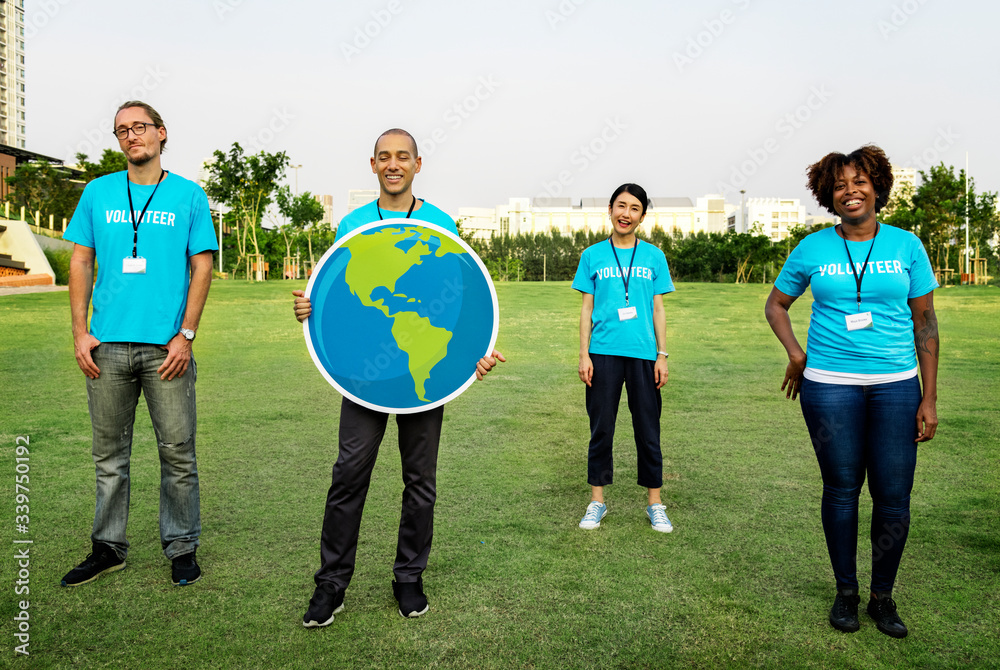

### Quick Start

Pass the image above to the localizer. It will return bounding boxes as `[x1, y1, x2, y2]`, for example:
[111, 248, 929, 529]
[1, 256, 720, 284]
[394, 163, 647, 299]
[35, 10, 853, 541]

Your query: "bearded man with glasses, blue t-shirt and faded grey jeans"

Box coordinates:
[62, 101, 218, 586]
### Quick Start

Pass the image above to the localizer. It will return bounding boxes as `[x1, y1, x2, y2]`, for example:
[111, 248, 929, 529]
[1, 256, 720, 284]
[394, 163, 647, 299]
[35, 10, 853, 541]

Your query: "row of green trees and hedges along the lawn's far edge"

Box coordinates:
[7, 148, 1000, 282]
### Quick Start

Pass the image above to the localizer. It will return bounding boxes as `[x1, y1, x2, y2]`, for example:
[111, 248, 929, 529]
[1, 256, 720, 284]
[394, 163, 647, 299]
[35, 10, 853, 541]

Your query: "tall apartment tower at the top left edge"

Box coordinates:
[0, 0, 25, 149]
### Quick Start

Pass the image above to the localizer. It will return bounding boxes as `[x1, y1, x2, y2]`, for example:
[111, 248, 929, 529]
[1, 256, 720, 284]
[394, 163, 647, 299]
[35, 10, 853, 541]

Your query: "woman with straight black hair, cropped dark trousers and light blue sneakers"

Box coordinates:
[573, 184, 674, 533]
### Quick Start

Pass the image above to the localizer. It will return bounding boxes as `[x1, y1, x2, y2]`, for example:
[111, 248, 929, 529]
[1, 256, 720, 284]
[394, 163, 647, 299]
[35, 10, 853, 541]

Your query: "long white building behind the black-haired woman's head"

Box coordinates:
[458, 195, 733, 239]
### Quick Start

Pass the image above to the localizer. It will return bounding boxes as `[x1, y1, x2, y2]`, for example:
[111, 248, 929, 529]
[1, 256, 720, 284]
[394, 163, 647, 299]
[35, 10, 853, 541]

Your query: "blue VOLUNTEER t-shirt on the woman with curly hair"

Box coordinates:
[774, 223, 938, 374]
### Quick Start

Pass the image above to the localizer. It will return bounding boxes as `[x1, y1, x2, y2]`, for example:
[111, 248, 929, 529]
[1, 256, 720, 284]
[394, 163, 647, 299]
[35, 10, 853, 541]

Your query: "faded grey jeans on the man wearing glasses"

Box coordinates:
[87, 342, 201, 559]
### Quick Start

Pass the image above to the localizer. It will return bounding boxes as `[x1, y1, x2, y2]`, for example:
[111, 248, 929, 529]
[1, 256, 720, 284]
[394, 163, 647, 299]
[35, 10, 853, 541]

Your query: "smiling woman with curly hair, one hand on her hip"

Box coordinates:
[764, 145, 940, 637]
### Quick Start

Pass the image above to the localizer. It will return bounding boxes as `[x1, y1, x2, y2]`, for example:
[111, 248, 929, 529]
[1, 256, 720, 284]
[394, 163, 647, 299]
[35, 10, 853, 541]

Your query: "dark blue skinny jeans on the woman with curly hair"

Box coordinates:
[800, 377, 921, 593]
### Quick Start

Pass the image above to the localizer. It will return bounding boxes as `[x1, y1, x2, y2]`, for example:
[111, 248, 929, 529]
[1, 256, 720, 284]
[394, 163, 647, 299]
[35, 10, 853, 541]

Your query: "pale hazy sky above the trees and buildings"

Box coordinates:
[25, 0, 1000, 223]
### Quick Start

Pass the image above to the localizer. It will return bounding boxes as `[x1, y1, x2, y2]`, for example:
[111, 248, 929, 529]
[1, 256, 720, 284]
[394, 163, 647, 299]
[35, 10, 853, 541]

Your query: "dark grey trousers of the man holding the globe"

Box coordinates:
[315, 398, 444, 589]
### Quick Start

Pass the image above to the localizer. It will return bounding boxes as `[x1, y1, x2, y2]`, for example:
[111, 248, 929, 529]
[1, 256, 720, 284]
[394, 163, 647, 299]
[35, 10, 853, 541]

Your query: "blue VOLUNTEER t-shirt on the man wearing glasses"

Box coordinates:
[63, 172, 219, 344]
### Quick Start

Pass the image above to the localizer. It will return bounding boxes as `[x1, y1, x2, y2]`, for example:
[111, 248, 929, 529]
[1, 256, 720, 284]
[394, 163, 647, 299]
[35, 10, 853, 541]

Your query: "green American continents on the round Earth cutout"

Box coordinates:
[344, 227, 465, 402]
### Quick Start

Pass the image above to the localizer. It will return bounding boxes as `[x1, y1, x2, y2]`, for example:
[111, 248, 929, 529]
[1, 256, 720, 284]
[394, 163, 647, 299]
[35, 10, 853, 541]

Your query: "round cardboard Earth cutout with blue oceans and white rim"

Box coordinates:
[303, 218, 500, 414]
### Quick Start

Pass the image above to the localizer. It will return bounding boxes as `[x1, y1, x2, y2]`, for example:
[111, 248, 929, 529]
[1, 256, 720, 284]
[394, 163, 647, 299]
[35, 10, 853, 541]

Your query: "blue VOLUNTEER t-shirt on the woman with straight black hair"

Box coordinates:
[573, 240, 674, 361]
